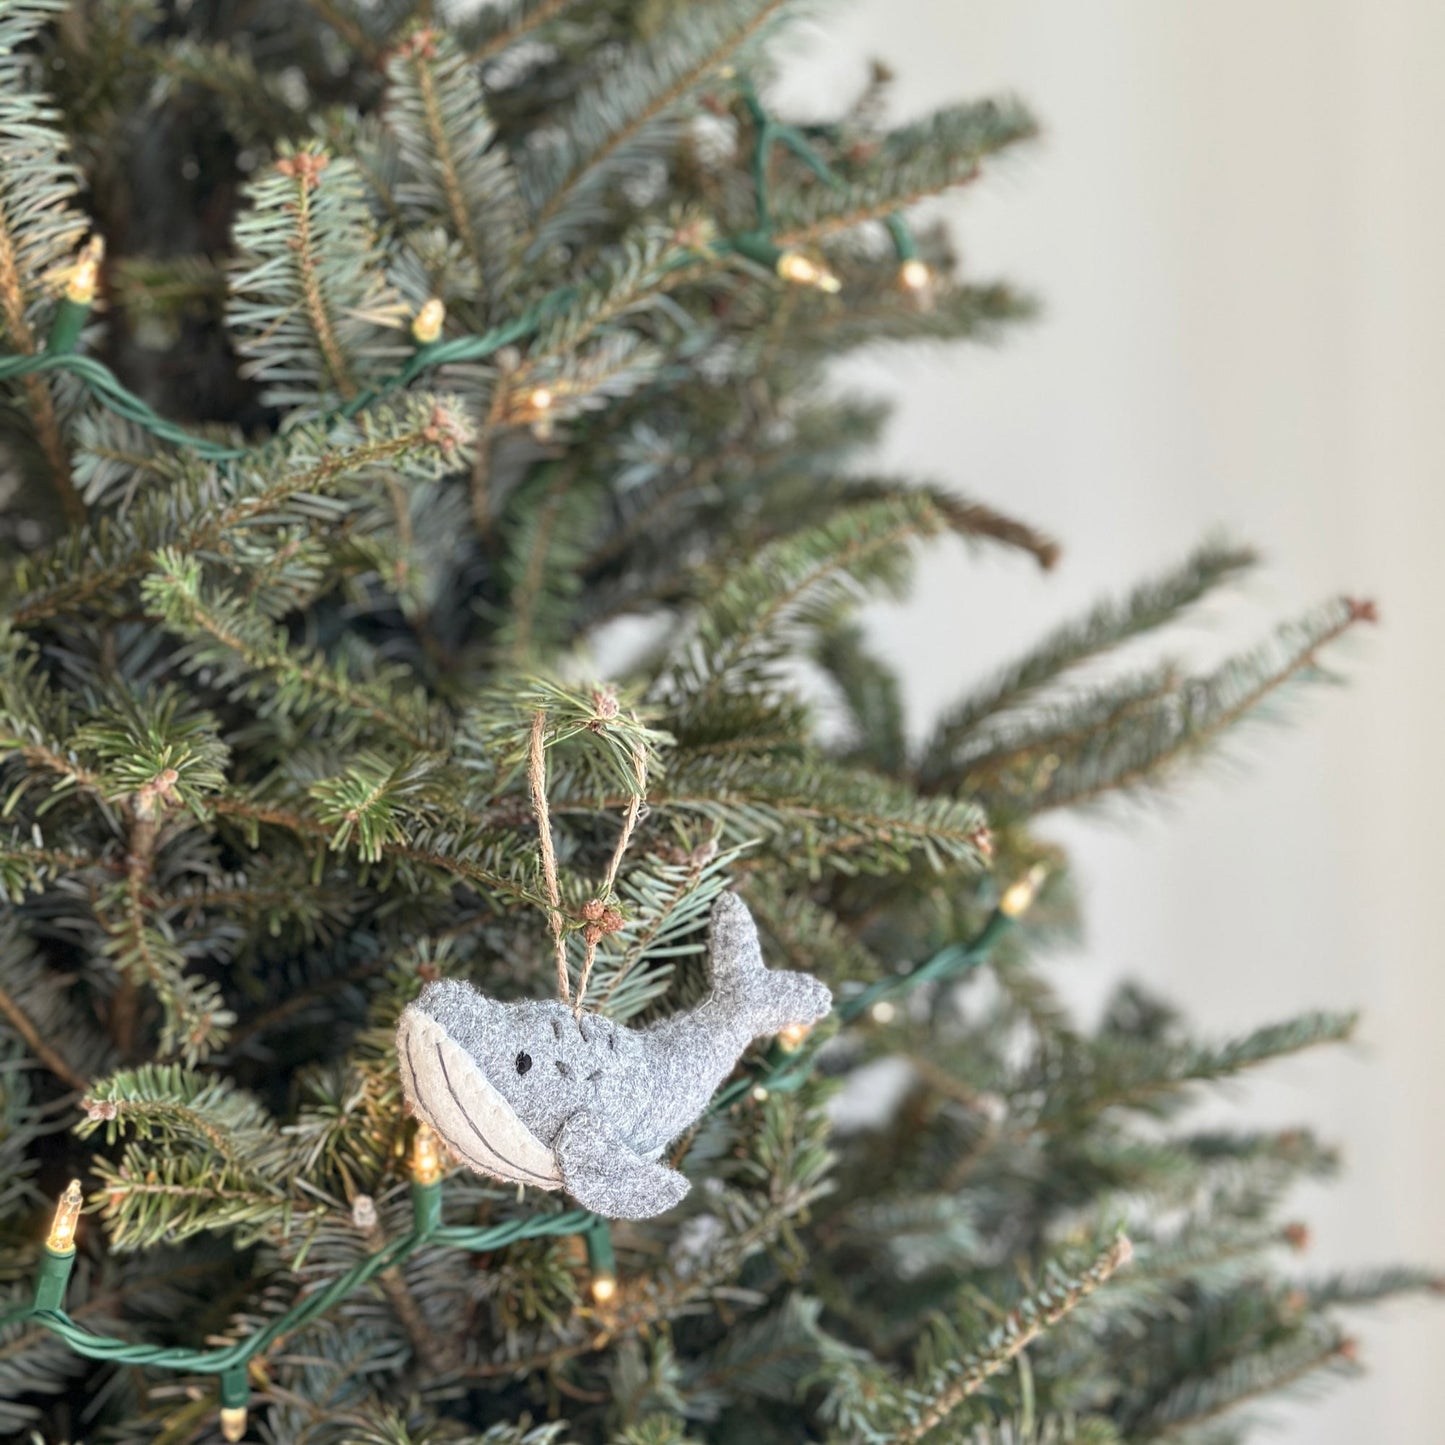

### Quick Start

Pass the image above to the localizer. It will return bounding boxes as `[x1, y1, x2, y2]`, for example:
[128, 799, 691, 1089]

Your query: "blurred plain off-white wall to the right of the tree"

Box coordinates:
[783, 0, 1445, 1445]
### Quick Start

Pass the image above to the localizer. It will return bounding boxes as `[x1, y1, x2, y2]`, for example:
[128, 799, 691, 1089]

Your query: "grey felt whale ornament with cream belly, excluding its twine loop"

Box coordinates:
[396, 893, 832, 1220]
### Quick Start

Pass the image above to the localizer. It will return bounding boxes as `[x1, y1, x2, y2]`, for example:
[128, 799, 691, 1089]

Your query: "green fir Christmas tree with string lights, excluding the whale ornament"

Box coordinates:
[0, 0, 1438, 1445]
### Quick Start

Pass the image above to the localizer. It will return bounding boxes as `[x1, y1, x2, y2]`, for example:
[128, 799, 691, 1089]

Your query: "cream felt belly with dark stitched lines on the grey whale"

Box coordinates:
[397, 1009, 562, 1189]
